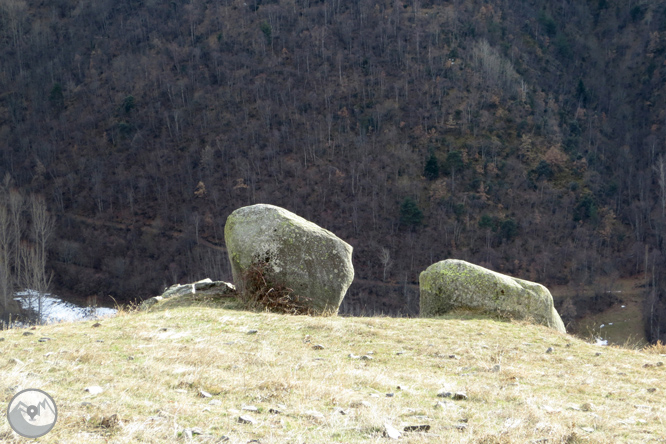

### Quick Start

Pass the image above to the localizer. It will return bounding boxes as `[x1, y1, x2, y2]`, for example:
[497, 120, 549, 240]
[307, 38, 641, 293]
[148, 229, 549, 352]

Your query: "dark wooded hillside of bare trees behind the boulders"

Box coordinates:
[0, 0, 666, 340]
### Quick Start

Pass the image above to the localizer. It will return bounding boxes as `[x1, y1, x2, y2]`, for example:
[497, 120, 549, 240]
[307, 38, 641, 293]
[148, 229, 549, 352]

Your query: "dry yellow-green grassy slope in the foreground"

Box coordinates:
[0, 300, 666, 443]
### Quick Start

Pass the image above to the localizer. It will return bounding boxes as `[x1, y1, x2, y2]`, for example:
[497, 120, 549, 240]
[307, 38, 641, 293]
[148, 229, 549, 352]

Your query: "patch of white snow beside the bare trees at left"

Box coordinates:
[14, 290, 117, 324]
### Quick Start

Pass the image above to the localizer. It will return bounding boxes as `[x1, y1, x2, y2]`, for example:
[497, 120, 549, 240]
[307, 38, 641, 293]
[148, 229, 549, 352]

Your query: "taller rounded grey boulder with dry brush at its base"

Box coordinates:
[224, 204, 354, 314]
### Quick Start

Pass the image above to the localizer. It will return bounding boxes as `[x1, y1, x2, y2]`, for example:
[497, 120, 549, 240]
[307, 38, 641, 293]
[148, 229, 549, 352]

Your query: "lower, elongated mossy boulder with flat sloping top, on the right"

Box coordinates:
[419, 259, 566, 333]
